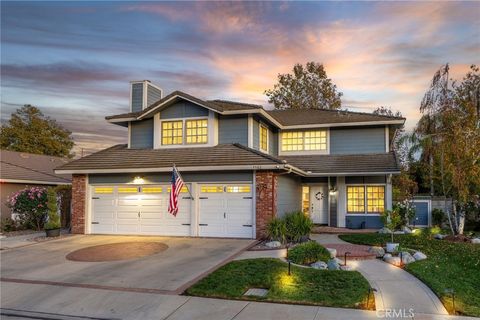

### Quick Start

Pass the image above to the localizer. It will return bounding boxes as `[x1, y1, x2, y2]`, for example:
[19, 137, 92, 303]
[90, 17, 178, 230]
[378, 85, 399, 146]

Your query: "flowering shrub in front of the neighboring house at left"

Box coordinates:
[7, 187, 47, 230]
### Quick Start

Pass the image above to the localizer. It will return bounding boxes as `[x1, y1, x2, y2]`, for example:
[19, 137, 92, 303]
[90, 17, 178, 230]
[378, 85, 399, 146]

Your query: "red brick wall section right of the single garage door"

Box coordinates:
[255, 171, 278, 239]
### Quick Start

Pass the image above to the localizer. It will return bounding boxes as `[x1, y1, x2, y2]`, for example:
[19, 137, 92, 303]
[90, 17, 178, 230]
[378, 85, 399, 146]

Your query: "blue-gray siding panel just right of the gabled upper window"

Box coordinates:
[218, 116, 248, 146]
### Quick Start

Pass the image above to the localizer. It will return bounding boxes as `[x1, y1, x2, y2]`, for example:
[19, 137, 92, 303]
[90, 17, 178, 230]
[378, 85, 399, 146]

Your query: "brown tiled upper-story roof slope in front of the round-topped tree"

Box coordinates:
[267, 109, 405, 126]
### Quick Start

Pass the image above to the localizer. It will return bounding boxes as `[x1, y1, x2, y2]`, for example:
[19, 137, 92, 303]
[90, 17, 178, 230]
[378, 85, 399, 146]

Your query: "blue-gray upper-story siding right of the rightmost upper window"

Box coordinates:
[330, 127, 385, 154]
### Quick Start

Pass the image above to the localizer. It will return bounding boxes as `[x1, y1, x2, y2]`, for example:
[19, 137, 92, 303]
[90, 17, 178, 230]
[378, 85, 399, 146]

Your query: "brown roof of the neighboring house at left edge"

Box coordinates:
[0, 150, 71, 185]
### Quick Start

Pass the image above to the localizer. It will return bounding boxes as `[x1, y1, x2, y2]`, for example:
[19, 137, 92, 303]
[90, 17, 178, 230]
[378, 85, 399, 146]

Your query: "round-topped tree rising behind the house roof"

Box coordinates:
[265, 62, 343, 109]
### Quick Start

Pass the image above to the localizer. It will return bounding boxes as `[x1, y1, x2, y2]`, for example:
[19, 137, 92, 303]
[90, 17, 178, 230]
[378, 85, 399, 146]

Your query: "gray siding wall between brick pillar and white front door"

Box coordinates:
[277, 175, 302, 217]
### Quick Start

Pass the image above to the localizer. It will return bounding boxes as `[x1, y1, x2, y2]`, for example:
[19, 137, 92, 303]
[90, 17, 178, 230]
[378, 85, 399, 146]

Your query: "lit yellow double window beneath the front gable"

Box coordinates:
[162, 119, 208, 145]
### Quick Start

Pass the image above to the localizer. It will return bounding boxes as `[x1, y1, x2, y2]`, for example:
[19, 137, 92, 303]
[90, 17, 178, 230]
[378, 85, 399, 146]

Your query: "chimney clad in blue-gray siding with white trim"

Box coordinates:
[130, 80, 163, 112]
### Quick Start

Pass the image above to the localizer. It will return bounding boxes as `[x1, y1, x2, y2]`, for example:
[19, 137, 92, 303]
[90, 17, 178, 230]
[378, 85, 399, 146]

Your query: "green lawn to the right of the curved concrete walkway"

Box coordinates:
[340, 232, 480, 317]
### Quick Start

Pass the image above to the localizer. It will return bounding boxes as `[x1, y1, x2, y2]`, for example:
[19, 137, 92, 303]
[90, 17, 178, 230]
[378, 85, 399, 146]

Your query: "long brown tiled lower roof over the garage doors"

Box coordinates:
[56, 144, 284, 173]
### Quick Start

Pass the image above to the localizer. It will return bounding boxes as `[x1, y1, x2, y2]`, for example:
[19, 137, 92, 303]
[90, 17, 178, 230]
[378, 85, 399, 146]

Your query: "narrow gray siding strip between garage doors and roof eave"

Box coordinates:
[88, 171, 253, 184]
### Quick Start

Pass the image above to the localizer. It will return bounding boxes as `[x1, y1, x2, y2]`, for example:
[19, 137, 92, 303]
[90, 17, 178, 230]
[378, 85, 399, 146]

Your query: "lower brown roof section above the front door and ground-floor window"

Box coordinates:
[280, 152, 400, 175]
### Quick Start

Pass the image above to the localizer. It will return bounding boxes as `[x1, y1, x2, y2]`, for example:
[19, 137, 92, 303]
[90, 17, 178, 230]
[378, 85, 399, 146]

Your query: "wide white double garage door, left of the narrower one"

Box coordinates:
[91, 185, 192, 236]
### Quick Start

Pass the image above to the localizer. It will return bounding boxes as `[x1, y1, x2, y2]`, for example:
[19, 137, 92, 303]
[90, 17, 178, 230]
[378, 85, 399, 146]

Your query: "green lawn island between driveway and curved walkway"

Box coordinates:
[186, 259, 374, 308]
